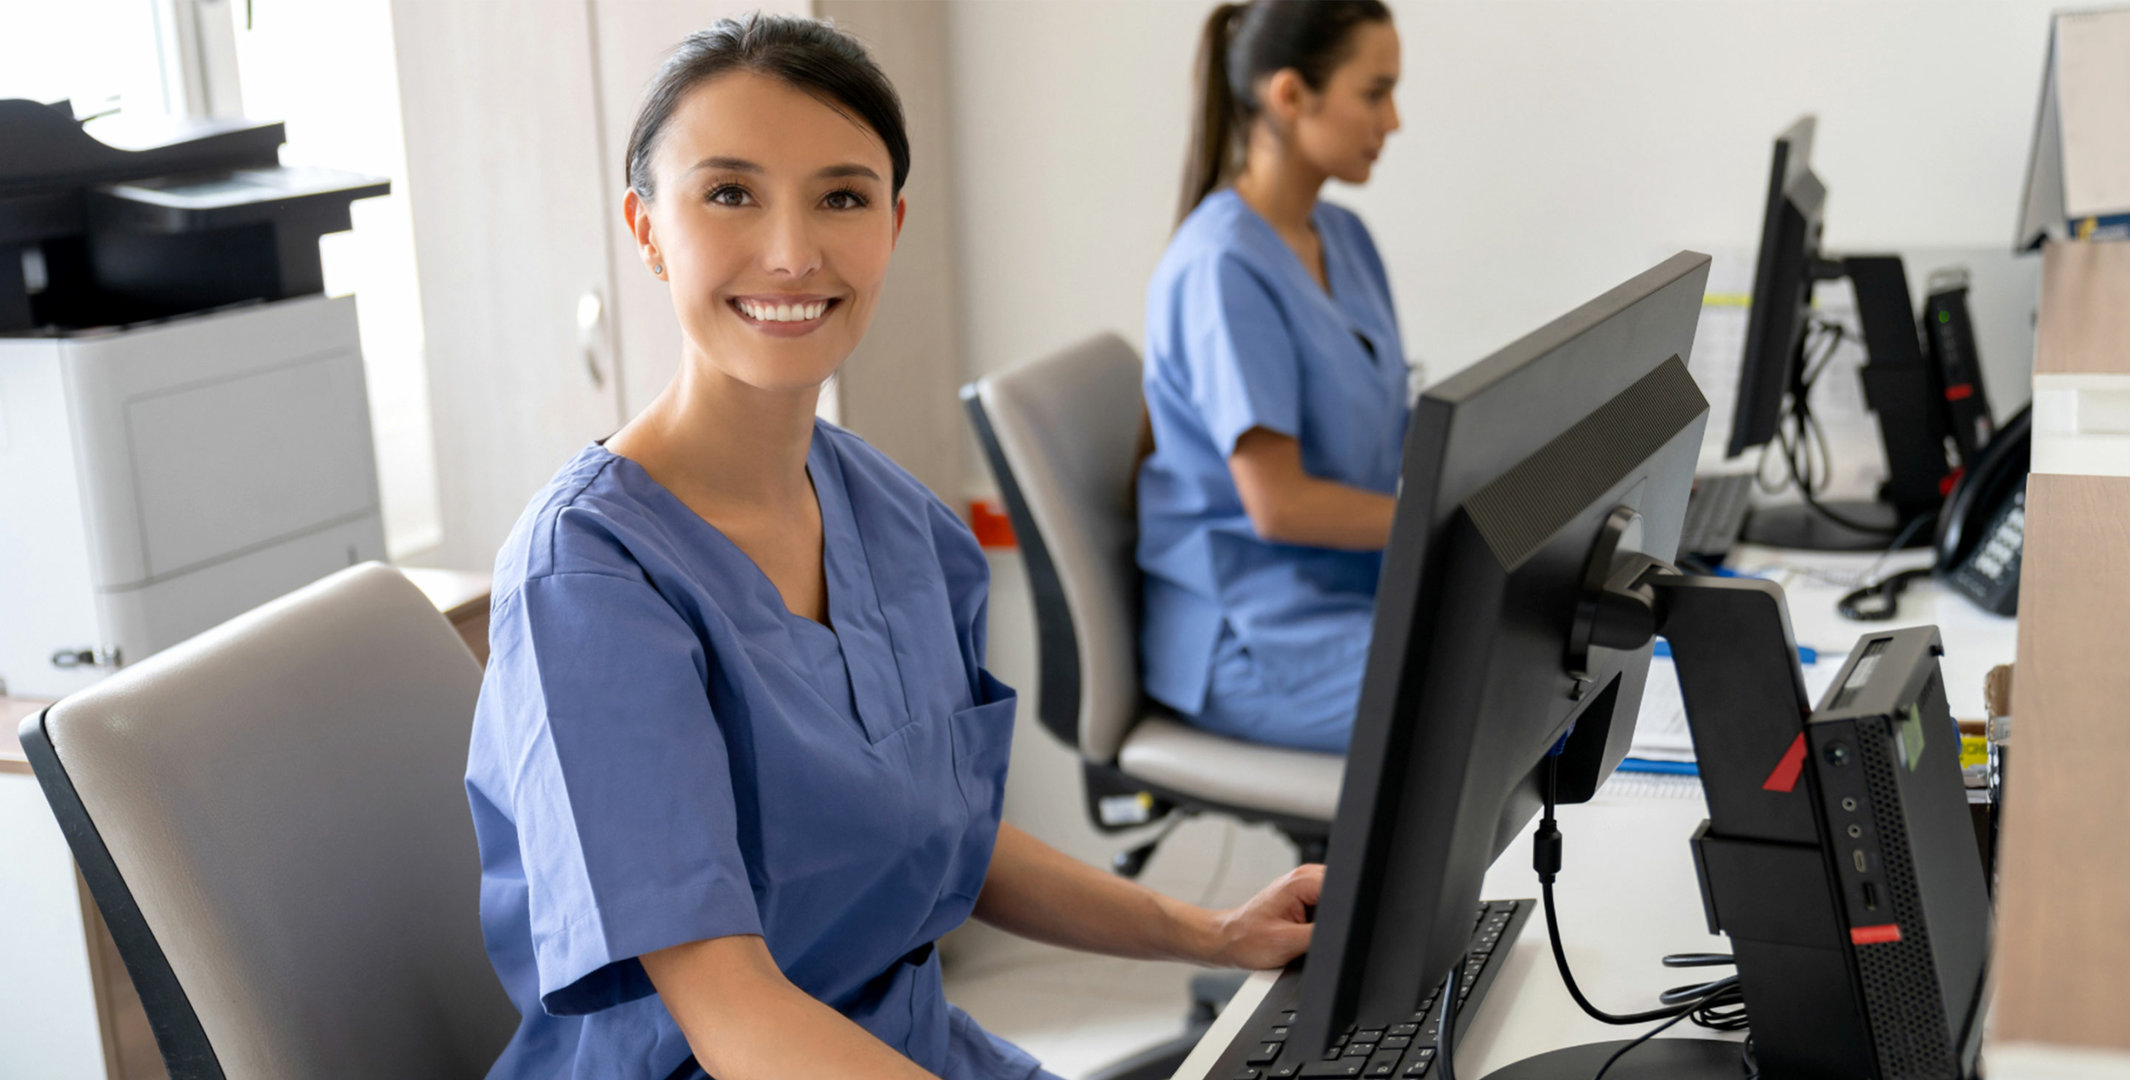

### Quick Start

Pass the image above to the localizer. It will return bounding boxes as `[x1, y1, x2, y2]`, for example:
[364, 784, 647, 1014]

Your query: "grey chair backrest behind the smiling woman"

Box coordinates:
[23, 562, 518, 1080]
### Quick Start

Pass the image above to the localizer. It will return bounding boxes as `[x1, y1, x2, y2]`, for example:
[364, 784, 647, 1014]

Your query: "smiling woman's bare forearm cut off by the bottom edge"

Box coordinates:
[641, 935, 933, 1080]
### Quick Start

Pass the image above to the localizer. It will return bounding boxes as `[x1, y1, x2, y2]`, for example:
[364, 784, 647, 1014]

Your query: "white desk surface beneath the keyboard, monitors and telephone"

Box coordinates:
[1176, 547, 2017, 1080]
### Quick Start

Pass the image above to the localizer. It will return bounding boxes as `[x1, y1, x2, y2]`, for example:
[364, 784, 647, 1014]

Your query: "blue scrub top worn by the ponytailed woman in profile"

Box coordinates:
[1137, 190, 1410, 737]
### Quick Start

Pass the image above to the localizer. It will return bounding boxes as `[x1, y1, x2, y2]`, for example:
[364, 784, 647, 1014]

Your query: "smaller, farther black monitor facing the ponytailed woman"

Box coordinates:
[1725, 117, 1828, 458]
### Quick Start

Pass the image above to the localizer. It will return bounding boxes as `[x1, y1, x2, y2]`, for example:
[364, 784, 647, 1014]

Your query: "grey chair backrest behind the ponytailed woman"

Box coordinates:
[963, 334, 1146, 765]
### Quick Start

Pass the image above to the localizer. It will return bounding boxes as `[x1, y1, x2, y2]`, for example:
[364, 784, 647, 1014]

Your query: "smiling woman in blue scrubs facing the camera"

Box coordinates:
[466, 17, 1321, 1080]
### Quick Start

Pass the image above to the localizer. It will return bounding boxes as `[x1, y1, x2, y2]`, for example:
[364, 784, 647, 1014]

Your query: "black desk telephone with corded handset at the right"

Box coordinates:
[1836, 405, 2034, 622]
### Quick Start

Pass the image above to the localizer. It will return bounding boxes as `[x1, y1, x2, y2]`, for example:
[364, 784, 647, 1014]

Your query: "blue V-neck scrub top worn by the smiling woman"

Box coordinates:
[466, 424, 1056, 1080]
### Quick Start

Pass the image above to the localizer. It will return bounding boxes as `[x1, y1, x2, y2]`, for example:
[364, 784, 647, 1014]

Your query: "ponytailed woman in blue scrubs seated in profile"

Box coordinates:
[1137, 0, 1410, 752]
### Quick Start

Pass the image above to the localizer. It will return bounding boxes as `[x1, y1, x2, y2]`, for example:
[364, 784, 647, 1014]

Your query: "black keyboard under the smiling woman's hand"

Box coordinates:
[1208, 899, 1538, 1080]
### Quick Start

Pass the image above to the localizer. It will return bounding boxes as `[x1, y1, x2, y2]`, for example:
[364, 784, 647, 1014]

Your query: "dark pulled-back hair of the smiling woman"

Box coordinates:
[622, 11, 910, 200]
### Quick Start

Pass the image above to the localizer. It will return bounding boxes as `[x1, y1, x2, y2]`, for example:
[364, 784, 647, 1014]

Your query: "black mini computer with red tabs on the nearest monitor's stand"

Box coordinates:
[1670, 613, 1989, 1080]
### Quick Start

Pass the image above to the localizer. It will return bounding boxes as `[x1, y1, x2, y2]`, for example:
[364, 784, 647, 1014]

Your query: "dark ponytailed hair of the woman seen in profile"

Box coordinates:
[1176, 0, 1391, 219]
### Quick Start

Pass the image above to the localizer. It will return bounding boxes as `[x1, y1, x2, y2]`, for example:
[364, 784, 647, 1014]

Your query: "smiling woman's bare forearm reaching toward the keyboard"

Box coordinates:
[976, 824, 1223, 963]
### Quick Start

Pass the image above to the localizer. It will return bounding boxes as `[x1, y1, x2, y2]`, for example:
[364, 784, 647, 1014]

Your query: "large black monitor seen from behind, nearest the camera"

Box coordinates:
[1293, 251, 1708, 1046]
